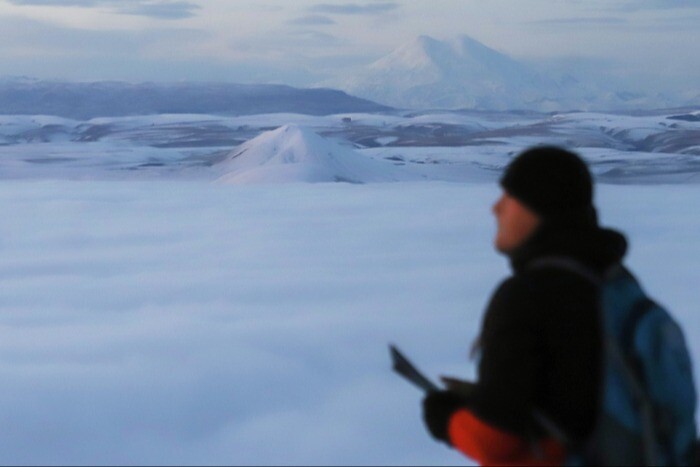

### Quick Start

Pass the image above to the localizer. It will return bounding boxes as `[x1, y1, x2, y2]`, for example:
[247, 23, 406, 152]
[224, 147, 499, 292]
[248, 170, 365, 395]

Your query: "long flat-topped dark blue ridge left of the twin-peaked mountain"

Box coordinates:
[0, 78, 388, 120]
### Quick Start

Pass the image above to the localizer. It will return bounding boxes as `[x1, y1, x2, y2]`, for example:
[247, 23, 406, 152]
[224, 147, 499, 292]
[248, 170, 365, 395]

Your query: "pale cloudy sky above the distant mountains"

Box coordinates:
[0, 0, 700, 91]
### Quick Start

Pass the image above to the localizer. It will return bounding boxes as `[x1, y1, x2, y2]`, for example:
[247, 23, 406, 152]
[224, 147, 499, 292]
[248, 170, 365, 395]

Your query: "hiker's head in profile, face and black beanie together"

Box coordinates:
[493, 146, 598, 254]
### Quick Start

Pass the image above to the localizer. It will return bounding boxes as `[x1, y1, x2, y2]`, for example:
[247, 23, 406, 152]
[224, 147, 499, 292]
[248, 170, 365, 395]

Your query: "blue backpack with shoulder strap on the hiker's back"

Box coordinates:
[531, 257, 697, 465]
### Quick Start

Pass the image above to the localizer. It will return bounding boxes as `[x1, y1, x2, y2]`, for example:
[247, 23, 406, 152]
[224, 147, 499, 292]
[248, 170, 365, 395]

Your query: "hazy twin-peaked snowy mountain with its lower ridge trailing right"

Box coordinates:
[326, 36, 700, 111]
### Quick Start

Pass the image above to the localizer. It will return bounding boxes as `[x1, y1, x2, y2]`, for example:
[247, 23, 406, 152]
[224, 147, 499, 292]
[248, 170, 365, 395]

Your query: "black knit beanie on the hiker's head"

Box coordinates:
[501, 146, 598, 227]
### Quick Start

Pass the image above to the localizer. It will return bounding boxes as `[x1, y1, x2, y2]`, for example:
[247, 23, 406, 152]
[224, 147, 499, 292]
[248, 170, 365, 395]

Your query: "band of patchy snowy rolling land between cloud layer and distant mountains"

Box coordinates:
[0, 110, 700, 184]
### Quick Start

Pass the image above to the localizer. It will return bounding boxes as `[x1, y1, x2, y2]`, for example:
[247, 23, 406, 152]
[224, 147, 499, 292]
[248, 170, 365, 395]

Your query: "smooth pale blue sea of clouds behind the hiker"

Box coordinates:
[0, 180, 700, 465]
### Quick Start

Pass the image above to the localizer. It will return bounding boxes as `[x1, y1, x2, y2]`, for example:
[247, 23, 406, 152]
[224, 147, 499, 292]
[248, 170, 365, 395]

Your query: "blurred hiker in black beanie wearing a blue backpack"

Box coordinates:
[423, 146, 697, 465]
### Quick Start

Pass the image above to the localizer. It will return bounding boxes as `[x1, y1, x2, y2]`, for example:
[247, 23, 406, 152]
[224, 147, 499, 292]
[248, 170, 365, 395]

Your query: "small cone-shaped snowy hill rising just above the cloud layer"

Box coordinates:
[218, 125, 416, 183]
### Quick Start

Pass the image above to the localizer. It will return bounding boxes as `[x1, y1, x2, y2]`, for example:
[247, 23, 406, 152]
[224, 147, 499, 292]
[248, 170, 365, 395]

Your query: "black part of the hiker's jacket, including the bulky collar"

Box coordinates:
[468, 225, 627, 441]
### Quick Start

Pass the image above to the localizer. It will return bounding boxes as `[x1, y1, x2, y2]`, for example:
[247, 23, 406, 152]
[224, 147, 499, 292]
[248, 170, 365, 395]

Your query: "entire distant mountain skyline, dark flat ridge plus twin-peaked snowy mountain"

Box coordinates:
[0, 36, 700, 116]
